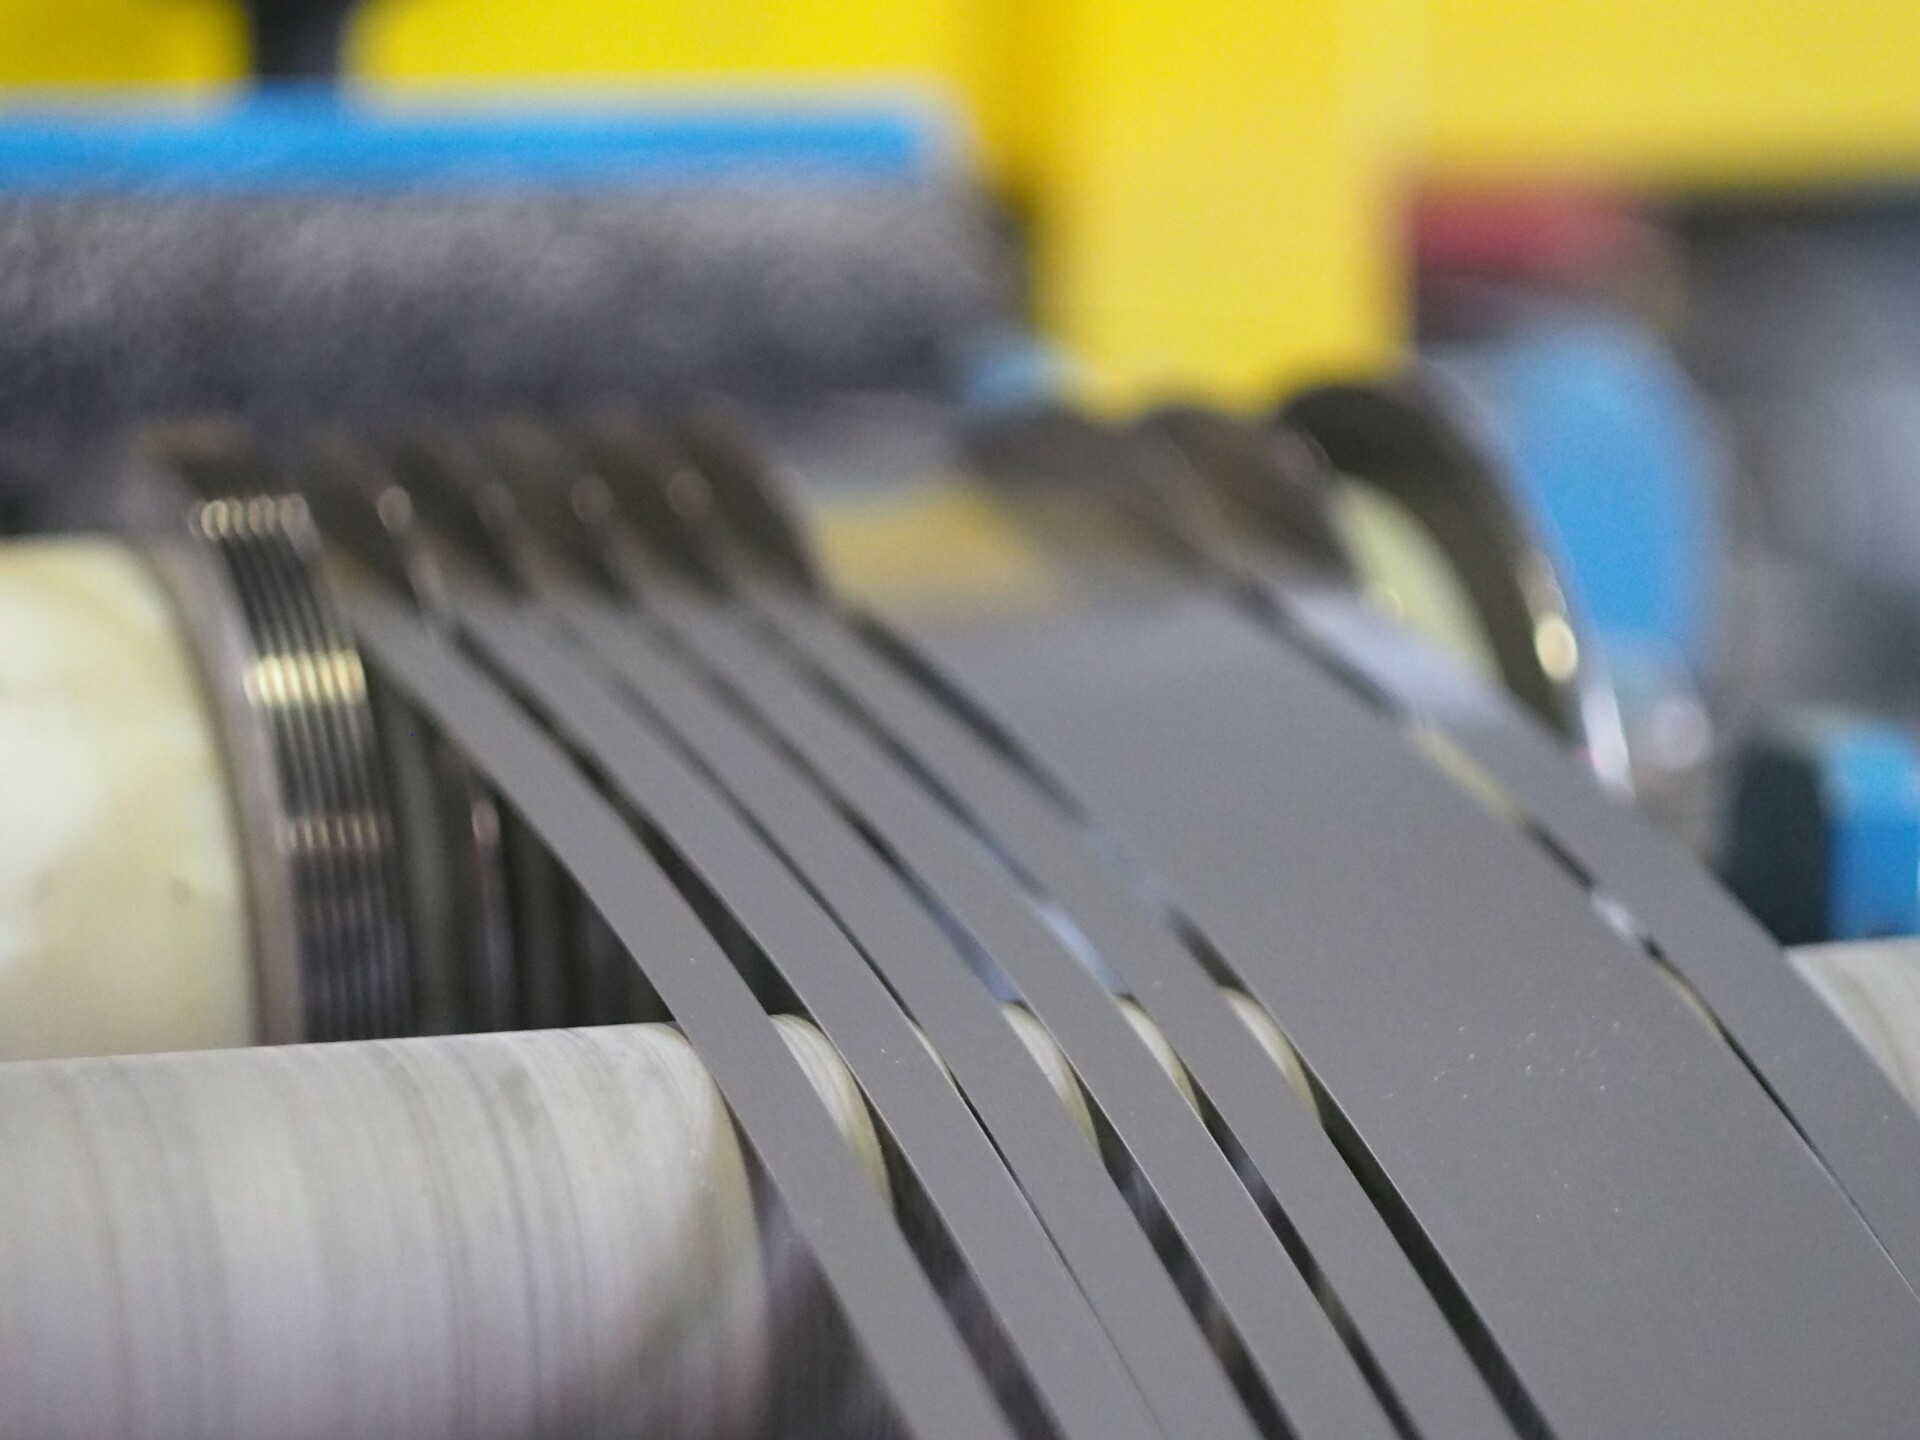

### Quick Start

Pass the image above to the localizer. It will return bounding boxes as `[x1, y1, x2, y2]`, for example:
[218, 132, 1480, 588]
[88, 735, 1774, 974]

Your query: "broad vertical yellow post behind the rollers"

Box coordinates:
[1016, 0, 1413, 405]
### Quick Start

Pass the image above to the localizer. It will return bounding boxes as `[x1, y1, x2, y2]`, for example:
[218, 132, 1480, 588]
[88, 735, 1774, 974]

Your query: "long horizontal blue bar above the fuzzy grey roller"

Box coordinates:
[0, 83, 962, 194]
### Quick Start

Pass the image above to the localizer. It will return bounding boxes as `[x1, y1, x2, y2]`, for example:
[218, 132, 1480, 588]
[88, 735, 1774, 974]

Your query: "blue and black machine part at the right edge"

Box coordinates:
[1726, 710, 1920, 945]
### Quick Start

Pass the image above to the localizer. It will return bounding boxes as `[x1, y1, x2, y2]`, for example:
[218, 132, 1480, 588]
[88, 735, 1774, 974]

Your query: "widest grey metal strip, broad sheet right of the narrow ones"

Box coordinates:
[875, 582, 1920, 1440]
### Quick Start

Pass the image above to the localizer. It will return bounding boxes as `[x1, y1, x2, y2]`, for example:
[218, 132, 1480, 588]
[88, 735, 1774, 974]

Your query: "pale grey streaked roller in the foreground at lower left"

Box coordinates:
[0, 1021, 885, 1440]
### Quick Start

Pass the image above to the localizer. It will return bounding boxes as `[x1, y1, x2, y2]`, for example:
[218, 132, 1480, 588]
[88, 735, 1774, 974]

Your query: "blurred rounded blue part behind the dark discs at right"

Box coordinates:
[1432, 307, 1724, 676]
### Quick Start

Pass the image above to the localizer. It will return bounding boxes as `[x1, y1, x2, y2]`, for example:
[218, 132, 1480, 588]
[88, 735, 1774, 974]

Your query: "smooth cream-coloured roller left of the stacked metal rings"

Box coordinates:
[0, 540, 257, 1059]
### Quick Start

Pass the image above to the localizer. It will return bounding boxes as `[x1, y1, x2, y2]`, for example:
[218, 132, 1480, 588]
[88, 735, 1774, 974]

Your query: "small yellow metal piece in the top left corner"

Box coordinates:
[0, 0, 246, 88]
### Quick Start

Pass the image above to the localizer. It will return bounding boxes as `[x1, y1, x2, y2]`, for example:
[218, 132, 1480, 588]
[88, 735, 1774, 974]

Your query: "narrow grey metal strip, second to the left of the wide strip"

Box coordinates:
[622, 587, 1392, 1440]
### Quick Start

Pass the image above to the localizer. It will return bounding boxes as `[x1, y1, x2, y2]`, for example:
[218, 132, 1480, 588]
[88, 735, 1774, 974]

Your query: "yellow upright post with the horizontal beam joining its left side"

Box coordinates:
[353, 0, 1417, 405]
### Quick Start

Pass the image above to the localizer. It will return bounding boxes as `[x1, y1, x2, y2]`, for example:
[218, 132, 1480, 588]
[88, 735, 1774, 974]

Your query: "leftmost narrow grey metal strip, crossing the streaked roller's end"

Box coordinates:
[342, 589, 1012, 1440]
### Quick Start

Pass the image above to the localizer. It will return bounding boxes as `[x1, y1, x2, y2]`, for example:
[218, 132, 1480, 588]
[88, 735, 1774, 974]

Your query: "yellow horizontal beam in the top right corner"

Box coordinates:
[1419, 0, 1920, 186]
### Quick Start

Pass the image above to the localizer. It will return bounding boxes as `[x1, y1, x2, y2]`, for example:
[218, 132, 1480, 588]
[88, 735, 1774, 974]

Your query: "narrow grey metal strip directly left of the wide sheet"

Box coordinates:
[760, 597, 1505, 1440]
